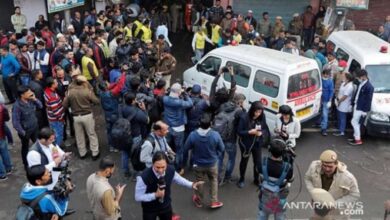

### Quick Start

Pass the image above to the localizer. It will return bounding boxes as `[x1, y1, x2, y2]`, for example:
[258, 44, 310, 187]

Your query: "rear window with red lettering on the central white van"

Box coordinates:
[287, 69, 320, 99]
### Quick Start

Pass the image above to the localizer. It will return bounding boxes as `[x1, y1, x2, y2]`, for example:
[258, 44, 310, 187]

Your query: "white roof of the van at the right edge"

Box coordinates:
[328, 31, 390, 62]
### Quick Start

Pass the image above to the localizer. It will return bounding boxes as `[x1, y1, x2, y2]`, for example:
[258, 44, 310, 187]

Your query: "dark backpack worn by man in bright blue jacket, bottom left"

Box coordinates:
[16, 192, 47, 220]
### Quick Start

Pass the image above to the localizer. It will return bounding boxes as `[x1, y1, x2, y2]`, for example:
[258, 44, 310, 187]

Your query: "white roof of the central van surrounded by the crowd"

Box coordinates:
[210, 45, 315, 70]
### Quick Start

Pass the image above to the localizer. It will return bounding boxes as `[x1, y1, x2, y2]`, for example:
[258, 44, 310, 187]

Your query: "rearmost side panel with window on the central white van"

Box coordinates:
[248, 70, 283, 133]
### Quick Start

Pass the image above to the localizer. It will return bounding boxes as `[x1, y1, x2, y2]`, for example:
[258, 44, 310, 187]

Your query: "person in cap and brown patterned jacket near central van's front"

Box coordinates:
[155, 48, 176, 88]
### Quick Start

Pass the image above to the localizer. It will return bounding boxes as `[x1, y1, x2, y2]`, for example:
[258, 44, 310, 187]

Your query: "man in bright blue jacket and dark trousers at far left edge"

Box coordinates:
[0, 46, 20, 103]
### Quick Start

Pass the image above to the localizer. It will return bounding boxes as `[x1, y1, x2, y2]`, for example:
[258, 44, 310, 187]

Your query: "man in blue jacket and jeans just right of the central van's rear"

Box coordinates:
[321, 69, 334, 136]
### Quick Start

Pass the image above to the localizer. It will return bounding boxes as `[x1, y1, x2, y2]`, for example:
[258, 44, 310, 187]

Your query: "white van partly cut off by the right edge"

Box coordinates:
[327, 31, 390, 137]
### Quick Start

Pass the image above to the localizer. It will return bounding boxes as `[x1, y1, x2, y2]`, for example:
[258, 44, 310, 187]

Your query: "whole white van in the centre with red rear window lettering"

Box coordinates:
[183, 45, 322, 131]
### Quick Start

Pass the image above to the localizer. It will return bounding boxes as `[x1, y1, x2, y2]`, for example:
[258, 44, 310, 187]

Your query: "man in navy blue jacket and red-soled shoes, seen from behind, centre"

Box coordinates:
[184, 113, 225, 208]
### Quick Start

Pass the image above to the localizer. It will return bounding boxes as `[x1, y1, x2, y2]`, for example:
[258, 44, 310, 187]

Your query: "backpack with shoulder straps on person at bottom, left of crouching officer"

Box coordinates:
[260, 157, 291, 213]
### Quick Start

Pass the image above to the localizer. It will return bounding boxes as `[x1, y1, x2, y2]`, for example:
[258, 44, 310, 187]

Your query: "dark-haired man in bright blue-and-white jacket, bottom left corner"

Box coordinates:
[20, 164, 71, 220]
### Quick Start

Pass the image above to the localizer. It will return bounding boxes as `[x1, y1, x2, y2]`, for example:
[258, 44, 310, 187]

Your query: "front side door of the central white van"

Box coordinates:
[191, 56, 222, 95]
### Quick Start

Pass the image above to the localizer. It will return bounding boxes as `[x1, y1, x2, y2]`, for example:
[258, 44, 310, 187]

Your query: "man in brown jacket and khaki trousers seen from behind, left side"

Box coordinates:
[62, 75, 99, 160]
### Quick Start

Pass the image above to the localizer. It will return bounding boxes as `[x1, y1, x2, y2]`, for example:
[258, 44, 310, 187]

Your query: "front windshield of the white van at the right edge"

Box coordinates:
[366, 65, 390, 93]
